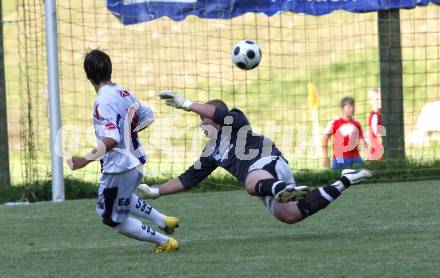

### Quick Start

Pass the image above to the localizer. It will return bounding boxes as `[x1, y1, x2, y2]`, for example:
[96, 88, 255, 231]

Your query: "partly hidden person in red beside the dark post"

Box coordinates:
[368, 88, 383, 160]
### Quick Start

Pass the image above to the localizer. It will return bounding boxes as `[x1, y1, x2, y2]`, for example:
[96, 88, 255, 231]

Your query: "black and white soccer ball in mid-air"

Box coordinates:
[231, 40, 261, 70]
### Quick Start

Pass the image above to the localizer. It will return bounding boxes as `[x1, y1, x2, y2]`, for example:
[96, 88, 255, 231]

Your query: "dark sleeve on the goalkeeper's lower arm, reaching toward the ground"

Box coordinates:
[179, 154, 217, 188]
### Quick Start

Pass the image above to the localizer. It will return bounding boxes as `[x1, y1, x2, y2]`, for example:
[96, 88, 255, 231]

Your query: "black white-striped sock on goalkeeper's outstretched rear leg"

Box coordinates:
[298, 177, 351, 218]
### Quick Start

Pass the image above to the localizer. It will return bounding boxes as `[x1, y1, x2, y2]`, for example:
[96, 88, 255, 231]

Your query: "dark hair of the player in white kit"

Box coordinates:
[84, 49, 112, 84]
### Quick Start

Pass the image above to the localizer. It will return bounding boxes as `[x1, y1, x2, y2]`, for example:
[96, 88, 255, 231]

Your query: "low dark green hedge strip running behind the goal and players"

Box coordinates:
[0, 161, 440, 203]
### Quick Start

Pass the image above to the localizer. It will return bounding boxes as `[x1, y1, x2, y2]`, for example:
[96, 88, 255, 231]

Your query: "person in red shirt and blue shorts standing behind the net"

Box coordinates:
[322, 97, 367, 170]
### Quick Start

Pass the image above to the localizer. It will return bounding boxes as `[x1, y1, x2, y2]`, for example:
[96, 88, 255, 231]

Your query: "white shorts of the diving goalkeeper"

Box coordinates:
[248, 156, 295, 212]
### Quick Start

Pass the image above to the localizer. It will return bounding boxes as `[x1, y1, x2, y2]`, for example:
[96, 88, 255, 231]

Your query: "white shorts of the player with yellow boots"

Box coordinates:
[96, 168, 144, 223]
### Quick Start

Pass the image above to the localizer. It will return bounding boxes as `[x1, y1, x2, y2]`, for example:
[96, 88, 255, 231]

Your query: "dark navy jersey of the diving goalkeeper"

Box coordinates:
[179, 108, 281, 188]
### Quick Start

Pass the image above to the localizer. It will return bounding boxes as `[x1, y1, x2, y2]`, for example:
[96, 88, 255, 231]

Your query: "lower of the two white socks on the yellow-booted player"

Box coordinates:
[115, 217, 169, 244]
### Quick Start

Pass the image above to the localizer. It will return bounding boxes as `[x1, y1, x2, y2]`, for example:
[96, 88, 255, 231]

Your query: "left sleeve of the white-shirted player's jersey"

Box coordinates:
[95, 104, 121, 143]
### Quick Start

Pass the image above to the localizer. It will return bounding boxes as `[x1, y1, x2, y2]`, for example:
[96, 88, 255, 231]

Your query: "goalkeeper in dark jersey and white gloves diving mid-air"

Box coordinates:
[138, 92, 372, 224]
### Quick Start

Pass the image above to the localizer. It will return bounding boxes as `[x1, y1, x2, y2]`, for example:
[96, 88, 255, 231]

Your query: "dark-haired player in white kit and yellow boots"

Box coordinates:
[67, 50, 179, 253]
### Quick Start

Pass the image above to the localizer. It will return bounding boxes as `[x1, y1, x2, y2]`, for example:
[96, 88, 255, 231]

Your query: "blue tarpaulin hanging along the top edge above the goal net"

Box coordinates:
[107, 0, 440, 24]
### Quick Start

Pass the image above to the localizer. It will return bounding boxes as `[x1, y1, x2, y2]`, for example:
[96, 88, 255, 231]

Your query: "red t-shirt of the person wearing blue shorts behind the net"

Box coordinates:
[325, 118, 364, 158]
